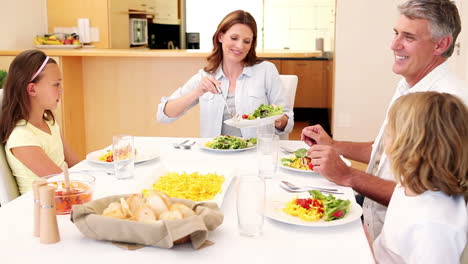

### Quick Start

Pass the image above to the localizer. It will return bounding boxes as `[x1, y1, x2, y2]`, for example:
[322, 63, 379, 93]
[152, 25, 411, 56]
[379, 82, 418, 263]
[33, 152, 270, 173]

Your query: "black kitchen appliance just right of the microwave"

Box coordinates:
[148, 23, 180, 49]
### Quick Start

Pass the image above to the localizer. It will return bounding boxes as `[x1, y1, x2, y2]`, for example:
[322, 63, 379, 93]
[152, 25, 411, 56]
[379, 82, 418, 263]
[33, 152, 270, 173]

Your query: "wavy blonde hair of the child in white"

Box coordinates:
[386, 92, 468, 195]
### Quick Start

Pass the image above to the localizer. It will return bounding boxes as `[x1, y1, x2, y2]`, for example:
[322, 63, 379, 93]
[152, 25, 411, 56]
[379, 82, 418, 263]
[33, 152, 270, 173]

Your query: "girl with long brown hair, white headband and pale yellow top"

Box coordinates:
[0, 50, 79, 194]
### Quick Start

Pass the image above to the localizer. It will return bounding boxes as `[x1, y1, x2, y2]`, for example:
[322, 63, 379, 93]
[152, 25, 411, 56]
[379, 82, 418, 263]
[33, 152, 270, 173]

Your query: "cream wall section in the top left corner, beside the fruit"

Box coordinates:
[0, 0, 47, 49]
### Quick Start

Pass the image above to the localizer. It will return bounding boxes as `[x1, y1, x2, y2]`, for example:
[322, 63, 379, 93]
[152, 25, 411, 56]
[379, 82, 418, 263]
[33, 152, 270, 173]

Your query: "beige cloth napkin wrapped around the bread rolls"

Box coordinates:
[71, 194, 224, 249]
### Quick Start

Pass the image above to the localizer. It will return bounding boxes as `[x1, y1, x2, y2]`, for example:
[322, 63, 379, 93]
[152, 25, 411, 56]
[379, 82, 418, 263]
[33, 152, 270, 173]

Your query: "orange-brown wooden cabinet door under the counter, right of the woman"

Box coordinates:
[280, 60, 331, 108]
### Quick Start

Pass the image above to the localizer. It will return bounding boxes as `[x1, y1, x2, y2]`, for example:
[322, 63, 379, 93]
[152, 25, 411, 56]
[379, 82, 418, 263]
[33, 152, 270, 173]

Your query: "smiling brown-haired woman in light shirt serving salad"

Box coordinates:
[157, 10, 294, 138]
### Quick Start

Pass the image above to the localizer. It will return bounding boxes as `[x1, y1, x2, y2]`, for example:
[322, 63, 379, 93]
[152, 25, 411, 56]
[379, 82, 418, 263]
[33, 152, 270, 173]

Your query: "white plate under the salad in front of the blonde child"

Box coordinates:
[265, 193, 362, 227]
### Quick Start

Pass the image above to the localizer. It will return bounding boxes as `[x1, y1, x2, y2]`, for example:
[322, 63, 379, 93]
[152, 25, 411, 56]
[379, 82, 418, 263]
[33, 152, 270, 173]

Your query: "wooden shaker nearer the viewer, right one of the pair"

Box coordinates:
[39, 185, 60, 244]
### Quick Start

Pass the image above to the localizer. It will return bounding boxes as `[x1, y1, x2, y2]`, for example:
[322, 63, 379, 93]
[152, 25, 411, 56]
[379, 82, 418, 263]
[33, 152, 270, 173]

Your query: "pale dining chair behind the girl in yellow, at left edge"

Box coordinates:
[0, 89, 20, 205]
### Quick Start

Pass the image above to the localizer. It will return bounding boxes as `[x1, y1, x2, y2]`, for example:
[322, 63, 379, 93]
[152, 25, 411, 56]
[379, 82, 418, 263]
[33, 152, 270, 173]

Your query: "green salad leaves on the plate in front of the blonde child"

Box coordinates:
[309, 190, 351, 221]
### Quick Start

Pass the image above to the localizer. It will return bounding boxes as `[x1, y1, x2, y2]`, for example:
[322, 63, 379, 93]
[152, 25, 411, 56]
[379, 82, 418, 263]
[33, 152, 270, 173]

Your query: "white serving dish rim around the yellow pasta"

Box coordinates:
[137, 163, 234, 207]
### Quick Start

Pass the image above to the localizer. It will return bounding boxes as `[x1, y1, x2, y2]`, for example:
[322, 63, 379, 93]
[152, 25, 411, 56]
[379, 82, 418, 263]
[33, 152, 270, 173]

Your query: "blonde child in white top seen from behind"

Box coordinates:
[374, 92, 468, 264]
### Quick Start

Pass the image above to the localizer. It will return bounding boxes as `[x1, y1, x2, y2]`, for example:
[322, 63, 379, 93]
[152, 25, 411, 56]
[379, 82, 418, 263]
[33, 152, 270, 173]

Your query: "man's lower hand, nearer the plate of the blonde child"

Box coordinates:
[307, 145, 351, 186]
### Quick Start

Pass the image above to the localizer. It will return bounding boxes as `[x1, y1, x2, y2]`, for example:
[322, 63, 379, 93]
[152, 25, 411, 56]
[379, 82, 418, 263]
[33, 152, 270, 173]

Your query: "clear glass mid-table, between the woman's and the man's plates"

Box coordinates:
[257, 134, 279, 179]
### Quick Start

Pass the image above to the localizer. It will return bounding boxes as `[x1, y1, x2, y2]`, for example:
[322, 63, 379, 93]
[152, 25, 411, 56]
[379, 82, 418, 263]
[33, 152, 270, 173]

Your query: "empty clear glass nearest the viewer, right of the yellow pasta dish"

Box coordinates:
[237, 175, 265, 236]
